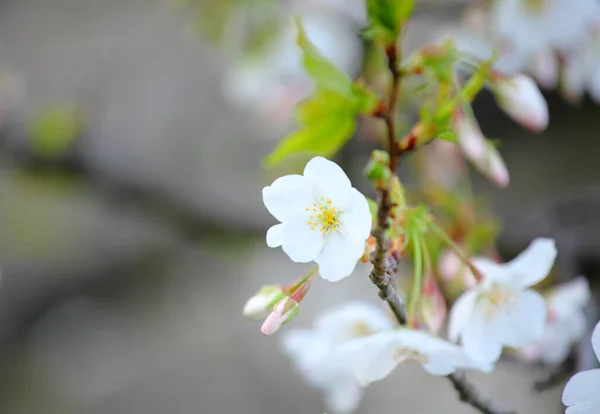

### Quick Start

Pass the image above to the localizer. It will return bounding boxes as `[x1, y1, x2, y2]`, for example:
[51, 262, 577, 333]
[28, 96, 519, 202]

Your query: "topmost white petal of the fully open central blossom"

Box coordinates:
[304, 157, 352, 210]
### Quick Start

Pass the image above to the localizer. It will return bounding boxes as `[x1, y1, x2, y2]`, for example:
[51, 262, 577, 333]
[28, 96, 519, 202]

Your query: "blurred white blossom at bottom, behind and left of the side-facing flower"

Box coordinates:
[281, 302, 394, 413]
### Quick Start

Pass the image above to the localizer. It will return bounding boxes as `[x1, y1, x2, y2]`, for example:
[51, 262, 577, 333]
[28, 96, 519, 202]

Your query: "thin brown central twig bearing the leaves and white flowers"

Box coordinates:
[369, 41, 504, 414]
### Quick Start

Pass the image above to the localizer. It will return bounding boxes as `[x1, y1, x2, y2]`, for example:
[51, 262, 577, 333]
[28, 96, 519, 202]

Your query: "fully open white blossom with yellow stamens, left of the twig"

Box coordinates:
[263, 157, 372, 282]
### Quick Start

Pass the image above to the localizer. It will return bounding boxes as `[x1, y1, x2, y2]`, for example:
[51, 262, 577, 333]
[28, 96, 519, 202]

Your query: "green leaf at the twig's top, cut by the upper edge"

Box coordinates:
[364, 0, 415, 44]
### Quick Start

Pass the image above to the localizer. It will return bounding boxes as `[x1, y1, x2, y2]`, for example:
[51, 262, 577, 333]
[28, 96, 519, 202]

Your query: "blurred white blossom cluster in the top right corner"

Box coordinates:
[451, 0, 600, 103]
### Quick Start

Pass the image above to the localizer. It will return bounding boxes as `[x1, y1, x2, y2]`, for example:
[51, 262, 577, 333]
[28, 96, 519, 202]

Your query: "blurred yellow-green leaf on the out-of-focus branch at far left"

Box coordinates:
[29, 107, 82, 157]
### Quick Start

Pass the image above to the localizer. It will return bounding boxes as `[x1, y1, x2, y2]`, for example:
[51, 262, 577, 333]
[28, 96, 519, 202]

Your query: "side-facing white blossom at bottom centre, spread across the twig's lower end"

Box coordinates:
[340, 328, 492, 386]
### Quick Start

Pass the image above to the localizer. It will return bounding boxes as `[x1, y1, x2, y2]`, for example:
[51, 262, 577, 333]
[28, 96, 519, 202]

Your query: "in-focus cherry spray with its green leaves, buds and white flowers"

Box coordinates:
[234, 0, 596, 413]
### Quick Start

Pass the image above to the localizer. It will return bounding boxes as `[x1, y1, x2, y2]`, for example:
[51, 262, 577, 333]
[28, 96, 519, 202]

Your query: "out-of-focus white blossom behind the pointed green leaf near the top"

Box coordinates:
[223, 5, 364, 129]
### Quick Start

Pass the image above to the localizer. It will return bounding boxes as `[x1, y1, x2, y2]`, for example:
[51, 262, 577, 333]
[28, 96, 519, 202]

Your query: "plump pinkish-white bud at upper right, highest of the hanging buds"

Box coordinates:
[495, 74, 548, 132]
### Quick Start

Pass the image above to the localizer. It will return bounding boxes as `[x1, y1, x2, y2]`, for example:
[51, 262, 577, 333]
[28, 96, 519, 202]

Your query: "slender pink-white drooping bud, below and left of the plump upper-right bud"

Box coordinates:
[454, 112, 509, 187]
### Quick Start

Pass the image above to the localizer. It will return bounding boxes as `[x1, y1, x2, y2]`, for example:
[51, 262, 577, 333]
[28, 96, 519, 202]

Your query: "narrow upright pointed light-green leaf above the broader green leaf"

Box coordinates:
[296, 18, 354, 98]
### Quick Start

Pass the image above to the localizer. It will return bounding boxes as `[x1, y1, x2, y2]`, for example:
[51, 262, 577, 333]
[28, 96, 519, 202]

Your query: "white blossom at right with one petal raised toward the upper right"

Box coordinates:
[449, 238, 556, 362]
